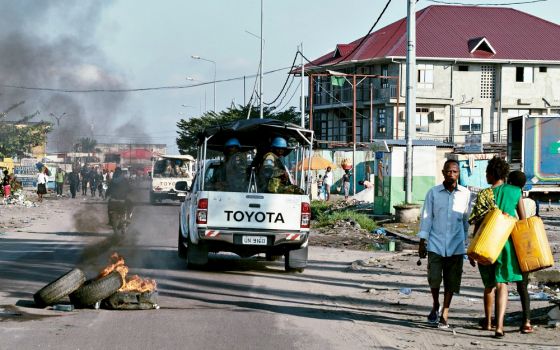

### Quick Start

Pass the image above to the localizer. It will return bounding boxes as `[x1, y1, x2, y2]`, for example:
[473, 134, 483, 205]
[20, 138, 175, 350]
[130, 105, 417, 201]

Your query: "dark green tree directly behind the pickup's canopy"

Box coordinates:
[177, 105, 301, 157]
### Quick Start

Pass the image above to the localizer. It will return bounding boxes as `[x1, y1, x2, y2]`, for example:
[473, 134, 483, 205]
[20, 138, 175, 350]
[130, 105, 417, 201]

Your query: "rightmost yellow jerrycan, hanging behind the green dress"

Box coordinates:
[511, 216, 554, 272]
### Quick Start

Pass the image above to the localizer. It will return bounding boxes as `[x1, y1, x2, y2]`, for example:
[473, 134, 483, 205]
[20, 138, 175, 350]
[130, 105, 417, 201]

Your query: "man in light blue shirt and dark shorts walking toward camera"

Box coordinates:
[418, 159, 471, 328]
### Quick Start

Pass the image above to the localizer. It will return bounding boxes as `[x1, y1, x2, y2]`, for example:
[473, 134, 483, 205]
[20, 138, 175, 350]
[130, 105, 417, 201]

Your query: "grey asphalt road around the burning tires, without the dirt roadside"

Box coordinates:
[0, 191, 380, 349]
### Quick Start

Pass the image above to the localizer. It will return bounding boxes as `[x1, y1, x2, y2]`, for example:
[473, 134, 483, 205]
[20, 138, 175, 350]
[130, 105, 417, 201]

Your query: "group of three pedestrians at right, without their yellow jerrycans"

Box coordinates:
[418, 157, 538, 338]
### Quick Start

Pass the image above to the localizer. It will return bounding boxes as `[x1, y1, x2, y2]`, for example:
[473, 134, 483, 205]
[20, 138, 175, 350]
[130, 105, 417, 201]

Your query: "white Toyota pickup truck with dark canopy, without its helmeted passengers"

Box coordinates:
[176, 119, 313, 272]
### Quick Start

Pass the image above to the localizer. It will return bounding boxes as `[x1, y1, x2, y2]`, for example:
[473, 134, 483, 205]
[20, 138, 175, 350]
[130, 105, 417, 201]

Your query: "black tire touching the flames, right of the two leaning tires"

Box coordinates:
[70, 271, 123, 306]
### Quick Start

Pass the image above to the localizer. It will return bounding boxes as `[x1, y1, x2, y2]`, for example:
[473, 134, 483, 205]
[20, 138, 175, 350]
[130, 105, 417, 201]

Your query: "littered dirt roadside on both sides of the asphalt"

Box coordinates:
[0, 193, 560, 349]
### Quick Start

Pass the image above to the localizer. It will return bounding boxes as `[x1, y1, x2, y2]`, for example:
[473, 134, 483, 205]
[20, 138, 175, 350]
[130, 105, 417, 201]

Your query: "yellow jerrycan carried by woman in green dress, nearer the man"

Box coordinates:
[467, 209, 517, 265]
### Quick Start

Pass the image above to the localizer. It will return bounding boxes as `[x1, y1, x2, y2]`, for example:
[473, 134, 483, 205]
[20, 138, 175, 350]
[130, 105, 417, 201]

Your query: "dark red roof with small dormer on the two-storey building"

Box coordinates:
[311, 5, 560, 65]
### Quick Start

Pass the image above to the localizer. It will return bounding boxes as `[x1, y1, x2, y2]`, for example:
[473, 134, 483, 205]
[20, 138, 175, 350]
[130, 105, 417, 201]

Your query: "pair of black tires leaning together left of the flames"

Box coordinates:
[33, 268, 123, 307]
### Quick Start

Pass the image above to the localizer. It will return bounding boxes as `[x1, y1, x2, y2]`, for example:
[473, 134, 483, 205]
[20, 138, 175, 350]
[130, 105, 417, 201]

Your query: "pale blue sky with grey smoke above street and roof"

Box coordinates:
[0, 0, 560, 153]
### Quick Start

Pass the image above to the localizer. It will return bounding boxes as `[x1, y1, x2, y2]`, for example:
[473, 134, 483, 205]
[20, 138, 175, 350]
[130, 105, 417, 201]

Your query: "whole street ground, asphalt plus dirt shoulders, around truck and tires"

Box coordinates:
[0, 191, 559, 350]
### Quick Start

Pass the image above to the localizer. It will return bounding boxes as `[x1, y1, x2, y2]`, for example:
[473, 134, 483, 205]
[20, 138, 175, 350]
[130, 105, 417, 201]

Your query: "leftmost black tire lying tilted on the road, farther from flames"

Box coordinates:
[33, 269, 86, 307]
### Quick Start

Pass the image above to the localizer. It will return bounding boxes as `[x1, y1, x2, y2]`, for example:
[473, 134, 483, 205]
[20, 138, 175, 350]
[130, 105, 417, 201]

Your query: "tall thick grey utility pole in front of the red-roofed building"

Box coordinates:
[405, 0, 416, 203]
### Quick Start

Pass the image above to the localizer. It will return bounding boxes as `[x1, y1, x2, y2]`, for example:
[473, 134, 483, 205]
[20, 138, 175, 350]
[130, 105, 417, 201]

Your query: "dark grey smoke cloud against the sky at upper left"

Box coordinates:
[0, 0, 151, 151]
